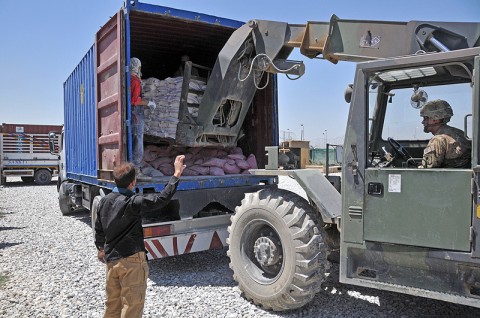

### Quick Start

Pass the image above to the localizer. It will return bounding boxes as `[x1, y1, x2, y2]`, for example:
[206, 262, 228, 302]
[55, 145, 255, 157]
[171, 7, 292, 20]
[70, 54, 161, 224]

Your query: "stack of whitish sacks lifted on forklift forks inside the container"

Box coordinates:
[142, 76, 206, 139]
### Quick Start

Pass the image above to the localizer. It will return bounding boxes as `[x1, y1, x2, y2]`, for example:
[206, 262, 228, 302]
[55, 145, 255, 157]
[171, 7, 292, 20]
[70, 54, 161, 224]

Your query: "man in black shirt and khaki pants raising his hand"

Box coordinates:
[95, 155, 185, 317]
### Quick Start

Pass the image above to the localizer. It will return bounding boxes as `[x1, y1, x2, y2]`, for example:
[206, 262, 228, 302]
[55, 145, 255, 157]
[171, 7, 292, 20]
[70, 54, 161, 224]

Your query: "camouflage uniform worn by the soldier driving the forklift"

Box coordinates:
[422, 125, 472, 168]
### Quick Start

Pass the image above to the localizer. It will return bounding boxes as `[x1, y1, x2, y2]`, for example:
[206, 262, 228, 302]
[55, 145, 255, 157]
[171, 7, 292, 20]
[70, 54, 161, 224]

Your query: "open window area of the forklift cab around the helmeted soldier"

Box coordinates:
[367, 65, 473, 168]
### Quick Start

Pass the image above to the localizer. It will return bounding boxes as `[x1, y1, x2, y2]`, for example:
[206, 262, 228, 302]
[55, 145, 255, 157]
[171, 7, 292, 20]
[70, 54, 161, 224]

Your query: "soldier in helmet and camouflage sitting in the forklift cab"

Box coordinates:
[420, 99, 472, 168]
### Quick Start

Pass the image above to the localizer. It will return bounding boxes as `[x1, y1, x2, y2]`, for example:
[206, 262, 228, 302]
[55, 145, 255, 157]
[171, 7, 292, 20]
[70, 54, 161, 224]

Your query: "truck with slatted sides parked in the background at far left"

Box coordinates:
[0, 123, 62, 185]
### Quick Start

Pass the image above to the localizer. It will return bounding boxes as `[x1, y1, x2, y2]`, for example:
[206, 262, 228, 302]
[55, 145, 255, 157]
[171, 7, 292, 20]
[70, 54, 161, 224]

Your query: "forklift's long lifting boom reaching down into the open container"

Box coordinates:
[176, 15, 480, 147]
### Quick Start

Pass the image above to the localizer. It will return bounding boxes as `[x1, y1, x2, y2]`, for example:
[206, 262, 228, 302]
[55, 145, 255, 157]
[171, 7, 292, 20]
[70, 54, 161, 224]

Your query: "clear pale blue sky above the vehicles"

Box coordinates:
[0, 0, 480, 147]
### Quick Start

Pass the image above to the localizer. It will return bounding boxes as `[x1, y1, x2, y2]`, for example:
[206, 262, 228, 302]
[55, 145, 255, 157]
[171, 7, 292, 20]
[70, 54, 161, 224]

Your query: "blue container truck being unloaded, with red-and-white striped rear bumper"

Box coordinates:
[58, 1, 278, 259]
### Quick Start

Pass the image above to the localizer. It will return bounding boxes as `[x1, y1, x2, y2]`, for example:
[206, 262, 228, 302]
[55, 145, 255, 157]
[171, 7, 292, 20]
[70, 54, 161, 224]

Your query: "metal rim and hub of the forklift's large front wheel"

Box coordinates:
[240, 219, 284, 284]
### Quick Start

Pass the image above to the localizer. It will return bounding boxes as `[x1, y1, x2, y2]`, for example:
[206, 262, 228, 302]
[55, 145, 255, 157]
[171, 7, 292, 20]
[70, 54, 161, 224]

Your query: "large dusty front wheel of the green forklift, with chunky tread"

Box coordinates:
[227, 189, 328, 311]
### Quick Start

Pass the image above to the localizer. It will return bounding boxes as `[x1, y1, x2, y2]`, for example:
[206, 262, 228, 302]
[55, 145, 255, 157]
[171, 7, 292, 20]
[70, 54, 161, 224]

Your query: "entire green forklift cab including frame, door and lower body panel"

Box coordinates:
[340, 48, 480, 304]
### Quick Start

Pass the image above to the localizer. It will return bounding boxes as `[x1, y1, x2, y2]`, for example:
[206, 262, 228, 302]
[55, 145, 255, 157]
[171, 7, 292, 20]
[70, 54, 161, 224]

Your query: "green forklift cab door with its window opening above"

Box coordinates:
[364, 58, 474, 252]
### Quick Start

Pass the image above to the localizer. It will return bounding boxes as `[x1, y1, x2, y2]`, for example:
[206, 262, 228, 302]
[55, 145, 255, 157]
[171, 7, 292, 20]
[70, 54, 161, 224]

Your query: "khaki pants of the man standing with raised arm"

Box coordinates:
[104, 252, 149, 318]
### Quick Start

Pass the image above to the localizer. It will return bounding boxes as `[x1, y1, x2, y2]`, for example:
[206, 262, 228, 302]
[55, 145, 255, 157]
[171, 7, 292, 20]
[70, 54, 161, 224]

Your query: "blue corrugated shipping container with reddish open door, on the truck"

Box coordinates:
[64, 1, 278, 191]
